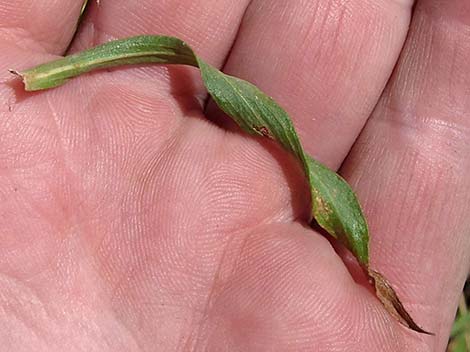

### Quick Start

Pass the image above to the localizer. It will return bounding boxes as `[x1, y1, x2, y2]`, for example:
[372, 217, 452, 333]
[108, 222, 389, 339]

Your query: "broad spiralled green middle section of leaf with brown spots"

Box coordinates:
[198, 58, 369, 265]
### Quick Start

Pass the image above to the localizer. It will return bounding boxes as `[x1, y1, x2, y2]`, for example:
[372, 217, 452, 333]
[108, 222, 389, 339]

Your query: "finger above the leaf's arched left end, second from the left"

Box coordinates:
[70, 0, 249, 66]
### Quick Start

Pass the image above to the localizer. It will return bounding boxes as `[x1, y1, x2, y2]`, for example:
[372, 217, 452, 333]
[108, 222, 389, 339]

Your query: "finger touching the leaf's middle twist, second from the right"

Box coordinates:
[210, 0, 412, 167]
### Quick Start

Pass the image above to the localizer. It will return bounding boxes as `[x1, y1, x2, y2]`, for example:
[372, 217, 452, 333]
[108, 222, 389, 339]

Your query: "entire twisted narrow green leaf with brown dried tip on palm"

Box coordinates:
[12, 36, 430, 332]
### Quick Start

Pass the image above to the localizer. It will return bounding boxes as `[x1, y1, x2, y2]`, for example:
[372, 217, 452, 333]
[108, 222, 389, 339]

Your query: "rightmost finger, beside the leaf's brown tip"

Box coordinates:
[343, 0, 470, 351]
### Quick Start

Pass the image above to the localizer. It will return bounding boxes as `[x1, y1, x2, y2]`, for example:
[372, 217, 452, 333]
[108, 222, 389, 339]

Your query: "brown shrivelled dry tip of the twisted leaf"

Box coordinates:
[367, 269, 434, 335]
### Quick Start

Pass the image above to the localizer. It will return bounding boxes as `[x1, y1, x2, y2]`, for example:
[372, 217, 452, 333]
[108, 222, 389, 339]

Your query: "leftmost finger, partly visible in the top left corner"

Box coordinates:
[0, 0, 83, 55]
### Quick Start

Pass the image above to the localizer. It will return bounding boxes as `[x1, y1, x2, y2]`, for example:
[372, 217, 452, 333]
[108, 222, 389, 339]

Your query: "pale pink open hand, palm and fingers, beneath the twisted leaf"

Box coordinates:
[0, 0, 470, 352]
